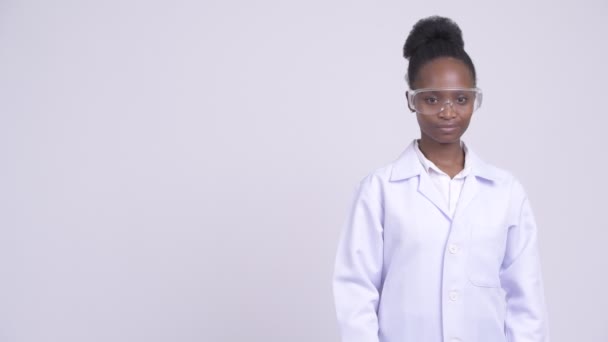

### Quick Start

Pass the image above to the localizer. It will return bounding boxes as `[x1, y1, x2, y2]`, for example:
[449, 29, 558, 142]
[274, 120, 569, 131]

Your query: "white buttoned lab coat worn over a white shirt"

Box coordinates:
[333, 143, 549, 342]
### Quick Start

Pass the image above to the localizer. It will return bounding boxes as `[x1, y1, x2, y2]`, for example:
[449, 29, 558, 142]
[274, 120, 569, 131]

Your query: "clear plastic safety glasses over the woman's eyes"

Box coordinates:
[407, 88, 482, 115]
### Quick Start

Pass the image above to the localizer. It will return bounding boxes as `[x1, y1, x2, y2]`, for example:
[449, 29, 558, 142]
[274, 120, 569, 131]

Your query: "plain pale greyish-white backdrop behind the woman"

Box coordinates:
[0, 0, 608, 342]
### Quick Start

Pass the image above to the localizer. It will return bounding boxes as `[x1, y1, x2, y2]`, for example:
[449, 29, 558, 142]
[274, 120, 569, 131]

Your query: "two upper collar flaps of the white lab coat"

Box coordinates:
[390, 141, 502, 182]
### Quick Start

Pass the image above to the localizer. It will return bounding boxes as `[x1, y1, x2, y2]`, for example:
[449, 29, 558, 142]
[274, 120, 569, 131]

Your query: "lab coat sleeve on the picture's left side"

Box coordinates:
[333, 183, 383, 342]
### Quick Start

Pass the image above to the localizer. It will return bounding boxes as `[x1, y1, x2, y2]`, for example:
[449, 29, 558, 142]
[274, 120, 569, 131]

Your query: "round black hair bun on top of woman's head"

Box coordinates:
[403, 16, 464, 59]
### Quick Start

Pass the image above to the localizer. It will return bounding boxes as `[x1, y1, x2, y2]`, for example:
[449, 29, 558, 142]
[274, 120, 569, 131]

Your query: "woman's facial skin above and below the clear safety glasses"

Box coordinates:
[414, 57, 475, 144]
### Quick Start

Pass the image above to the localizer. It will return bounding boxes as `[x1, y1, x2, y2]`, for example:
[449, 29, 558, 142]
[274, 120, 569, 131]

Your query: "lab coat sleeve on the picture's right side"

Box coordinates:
[500, 191, 549, 342]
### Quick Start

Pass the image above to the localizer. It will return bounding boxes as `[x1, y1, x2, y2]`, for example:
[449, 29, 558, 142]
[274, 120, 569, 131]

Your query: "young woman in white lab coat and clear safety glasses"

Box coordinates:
[333, 17, 548, 342]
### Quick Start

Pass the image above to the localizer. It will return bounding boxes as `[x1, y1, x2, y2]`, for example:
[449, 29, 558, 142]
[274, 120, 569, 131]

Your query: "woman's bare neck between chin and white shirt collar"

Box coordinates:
[418, 135, 464, 177]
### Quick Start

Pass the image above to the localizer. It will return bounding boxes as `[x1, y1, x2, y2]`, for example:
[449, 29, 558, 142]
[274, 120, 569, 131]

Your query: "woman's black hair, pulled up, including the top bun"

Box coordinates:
[403, 16, 477, 87]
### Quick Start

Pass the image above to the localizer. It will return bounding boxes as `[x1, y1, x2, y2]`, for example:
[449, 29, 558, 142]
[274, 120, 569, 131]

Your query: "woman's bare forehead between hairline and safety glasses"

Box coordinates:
[414, 57, 475, 88]
